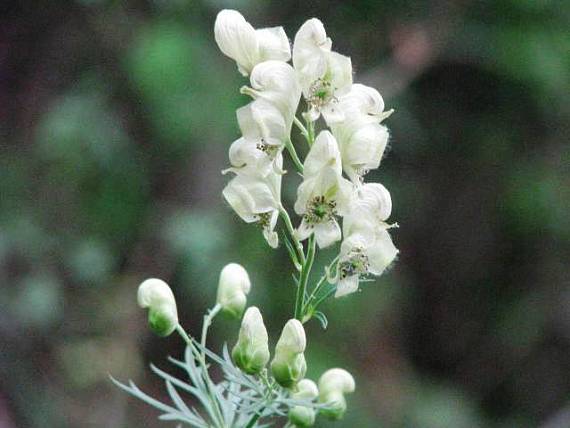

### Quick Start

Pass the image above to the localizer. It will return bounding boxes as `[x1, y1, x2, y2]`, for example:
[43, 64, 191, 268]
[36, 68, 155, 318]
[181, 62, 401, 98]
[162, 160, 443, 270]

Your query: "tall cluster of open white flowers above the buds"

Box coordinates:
[214, 10, 398, 297]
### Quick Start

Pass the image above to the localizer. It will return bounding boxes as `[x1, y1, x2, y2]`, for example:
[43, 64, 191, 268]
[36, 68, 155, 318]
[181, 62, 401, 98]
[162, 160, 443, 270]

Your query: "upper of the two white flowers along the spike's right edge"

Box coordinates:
[331, 84, 391, 182]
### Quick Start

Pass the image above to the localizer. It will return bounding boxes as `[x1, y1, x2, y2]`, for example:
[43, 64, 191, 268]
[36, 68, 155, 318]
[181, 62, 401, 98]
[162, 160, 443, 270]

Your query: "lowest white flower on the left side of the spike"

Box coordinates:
[222, 154, 283, 248]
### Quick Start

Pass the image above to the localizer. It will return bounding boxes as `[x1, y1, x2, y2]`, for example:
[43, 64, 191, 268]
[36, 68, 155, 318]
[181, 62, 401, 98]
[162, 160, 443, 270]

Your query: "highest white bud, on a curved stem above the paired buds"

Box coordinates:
[216, 263, 251, 318]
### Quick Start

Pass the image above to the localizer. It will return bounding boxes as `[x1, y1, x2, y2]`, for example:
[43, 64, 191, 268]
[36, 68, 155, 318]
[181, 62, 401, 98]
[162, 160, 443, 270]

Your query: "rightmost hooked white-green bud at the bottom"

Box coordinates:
[319, 369, 355, 420]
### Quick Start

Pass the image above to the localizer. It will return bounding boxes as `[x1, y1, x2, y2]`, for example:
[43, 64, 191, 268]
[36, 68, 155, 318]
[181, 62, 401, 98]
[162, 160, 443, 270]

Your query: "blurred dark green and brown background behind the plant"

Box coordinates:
[0, 0, 570, 428]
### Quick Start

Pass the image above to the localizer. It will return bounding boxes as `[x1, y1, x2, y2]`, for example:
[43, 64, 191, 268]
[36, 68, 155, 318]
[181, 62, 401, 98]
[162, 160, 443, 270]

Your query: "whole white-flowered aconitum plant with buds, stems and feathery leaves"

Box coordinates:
[114, 10, 398, 428]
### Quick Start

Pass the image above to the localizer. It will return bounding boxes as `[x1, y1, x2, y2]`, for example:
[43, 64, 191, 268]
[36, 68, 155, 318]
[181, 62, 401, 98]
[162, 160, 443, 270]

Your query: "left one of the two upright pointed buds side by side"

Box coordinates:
[232, 306, 270, 374]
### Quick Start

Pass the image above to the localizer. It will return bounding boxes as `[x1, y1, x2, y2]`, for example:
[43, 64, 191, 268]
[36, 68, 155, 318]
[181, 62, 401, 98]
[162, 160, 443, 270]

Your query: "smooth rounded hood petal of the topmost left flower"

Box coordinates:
[214, 9, 259, 76]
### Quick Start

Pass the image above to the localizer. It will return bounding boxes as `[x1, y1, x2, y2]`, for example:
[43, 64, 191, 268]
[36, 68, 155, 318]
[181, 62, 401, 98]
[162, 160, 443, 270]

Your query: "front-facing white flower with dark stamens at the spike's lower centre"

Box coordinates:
[295, 131, 352, 248]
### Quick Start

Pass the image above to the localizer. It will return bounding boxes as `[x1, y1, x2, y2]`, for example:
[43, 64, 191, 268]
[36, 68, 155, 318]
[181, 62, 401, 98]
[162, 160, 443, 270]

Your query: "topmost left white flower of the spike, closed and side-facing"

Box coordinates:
[214, 9, 291, 76]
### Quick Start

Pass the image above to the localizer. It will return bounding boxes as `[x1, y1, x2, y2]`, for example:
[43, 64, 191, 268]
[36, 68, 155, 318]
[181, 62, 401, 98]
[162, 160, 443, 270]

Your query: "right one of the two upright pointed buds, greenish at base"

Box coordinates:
[271, 319, 307, 388]
